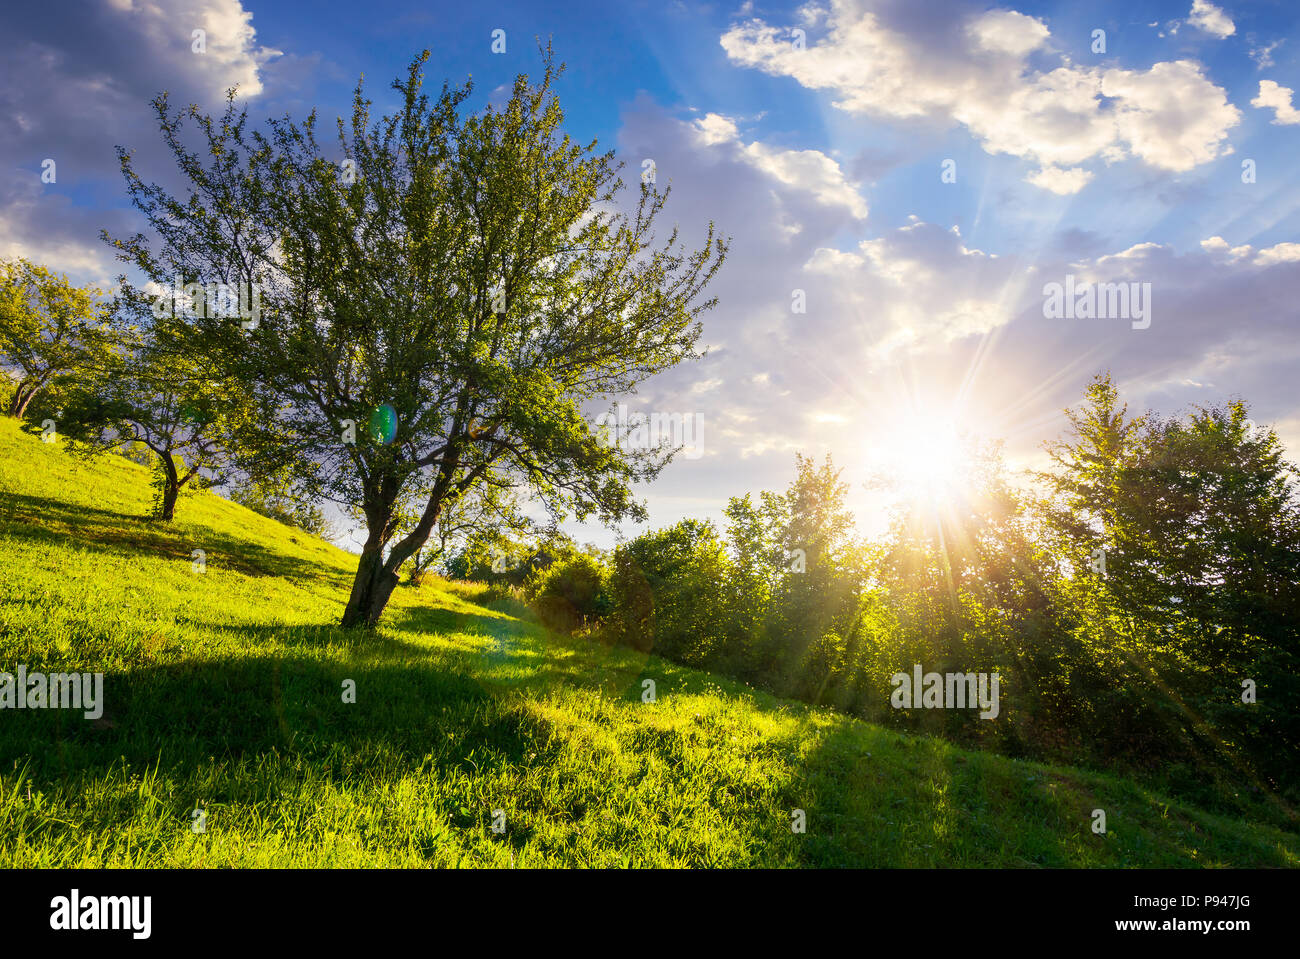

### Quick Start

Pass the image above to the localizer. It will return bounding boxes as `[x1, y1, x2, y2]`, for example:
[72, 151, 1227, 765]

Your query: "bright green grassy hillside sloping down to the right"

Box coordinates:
[0, 420, 1300, 867]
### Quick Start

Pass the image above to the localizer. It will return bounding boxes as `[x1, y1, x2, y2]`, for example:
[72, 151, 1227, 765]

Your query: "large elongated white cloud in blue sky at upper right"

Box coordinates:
[720, 0, 1240, 192]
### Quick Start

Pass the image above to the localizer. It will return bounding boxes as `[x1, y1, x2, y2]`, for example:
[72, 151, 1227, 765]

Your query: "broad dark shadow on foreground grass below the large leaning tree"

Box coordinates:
[0, 656, 550, 802]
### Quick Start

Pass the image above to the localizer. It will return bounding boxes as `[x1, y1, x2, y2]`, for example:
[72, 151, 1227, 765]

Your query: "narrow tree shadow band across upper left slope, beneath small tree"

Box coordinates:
[0, 494, 346, 585]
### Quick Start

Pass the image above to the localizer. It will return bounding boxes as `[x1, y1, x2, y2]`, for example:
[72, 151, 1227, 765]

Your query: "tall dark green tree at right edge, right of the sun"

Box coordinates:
[1044, 376, 1300, 785]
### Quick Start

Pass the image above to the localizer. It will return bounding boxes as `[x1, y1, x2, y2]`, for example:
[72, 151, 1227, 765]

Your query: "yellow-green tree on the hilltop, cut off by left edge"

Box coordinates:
[0, 259, 113, 417]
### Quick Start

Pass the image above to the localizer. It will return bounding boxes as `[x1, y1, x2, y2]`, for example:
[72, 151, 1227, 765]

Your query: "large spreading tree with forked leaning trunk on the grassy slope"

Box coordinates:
[106, 49, 725, 625]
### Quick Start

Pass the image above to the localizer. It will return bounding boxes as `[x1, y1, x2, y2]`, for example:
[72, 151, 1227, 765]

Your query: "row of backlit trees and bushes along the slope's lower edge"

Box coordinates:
[535, 377, 1300, 802]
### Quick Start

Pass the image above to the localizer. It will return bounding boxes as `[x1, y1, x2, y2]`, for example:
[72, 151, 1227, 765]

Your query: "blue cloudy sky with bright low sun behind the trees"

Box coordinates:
[0, 0, 1300, 546]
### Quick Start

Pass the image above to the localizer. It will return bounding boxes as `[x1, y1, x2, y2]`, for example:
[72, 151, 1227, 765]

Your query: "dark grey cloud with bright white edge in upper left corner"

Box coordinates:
[0, 0, 280, 283]
